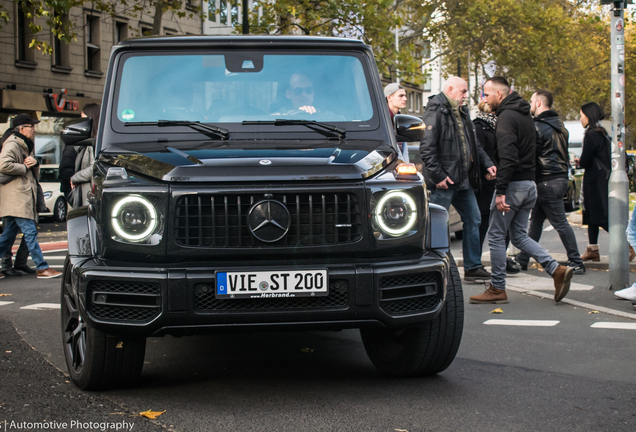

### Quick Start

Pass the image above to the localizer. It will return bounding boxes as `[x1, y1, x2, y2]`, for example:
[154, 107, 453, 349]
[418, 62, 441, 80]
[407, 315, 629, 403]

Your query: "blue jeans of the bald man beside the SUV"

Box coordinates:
[430, 188, 482, 270]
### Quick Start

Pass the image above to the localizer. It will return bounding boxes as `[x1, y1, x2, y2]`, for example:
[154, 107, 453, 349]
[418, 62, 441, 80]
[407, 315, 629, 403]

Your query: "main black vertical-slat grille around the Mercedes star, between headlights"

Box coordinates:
[174, 192, 362, 247]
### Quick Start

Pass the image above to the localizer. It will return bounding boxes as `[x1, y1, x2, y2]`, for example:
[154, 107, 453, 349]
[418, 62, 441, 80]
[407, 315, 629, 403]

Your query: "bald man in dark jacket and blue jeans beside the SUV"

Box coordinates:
[420, 77, 497, 281]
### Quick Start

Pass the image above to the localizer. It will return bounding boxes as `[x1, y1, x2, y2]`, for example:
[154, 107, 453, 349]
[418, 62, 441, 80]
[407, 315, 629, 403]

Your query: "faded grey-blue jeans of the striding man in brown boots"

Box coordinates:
[488, 180, 559, 289]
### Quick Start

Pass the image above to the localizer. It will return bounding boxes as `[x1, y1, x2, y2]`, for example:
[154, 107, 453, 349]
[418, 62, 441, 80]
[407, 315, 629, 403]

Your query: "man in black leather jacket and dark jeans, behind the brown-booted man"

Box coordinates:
[517, 90, 585, 274]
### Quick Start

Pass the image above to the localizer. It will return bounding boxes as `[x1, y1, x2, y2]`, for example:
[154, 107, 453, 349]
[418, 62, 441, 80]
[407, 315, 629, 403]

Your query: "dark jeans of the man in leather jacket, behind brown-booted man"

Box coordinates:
[517, 178, 583, 265]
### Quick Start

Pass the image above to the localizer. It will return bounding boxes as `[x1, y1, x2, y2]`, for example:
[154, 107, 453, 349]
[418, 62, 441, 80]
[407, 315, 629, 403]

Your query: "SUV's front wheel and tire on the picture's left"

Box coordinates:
[61, 256, 146, 390]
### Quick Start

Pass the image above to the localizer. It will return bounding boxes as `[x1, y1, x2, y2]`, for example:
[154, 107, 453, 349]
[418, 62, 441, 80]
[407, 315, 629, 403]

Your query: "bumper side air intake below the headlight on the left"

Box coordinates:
[88, 280, 161, 323]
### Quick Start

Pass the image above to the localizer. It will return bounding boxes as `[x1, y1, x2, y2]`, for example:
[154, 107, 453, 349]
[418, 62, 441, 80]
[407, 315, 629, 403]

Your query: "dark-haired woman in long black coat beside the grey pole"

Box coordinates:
[579, 102, 612, 261]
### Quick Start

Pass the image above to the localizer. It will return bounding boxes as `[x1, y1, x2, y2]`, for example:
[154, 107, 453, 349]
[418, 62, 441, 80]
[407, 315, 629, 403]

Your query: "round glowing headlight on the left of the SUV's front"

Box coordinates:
[111, 196, 158, 241]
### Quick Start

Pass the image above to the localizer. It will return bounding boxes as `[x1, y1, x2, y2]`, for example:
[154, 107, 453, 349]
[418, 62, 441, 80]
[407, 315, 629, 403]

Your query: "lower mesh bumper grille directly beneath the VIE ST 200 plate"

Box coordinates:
[194, 280, 348, 313]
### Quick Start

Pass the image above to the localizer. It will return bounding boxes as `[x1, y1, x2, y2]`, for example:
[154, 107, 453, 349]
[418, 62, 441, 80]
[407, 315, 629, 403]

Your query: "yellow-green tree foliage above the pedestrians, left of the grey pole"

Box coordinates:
[433, 0, 610, 119]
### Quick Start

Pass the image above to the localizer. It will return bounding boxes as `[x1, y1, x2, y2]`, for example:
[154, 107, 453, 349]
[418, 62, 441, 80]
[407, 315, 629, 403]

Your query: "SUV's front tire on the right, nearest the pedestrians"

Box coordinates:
[360, 256, 464, 377]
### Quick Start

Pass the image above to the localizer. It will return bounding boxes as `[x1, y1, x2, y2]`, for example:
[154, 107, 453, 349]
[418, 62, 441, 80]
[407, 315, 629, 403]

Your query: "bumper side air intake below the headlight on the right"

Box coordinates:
[380, 272, 442, 316]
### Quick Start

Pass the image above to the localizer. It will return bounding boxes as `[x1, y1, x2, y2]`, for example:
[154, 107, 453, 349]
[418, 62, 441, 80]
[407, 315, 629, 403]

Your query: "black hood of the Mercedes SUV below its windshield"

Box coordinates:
[98, 140, 396, 182]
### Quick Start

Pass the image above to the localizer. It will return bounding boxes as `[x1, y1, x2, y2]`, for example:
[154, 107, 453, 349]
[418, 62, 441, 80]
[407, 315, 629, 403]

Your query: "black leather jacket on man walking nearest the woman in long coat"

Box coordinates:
[534, 110, 570, 181]
